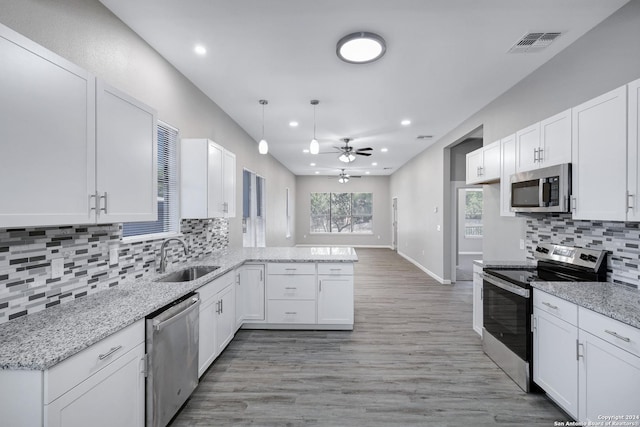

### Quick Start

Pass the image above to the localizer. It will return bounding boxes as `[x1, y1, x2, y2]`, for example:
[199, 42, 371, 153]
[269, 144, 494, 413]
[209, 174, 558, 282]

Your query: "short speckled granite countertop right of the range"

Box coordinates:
[531, 282, 640, 328]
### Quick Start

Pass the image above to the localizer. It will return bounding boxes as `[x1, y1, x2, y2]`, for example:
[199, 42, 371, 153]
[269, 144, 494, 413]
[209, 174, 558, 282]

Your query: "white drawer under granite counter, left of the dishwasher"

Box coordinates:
[44, 319, 144, 404]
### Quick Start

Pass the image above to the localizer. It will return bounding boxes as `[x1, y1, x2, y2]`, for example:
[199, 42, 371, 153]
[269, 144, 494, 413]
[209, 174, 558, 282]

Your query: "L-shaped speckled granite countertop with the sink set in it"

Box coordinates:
[0, 247, 358, 370]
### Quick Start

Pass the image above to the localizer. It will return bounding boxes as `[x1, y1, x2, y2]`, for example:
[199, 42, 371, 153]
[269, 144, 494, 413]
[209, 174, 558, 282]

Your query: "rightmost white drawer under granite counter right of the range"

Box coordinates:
[578, 307, 640, 356]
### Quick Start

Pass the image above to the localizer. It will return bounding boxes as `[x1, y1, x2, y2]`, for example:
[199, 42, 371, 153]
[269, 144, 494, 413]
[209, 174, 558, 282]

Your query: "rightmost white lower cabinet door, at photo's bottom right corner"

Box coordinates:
[576, 329, 640, 422]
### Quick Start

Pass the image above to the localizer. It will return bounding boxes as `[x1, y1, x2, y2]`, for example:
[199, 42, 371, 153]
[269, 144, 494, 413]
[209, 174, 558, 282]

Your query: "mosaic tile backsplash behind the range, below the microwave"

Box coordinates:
[526, 214, 640, 289]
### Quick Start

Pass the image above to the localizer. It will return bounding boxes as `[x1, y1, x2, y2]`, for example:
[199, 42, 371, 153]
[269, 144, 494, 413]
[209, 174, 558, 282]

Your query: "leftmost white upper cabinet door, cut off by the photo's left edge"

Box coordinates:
[0, 25, 95, 228]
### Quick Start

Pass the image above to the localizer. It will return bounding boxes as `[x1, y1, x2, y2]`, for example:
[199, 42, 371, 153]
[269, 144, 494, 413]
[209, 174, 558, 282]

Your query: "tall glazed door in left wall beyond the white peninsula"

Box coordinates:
[242, 169, 266, 248]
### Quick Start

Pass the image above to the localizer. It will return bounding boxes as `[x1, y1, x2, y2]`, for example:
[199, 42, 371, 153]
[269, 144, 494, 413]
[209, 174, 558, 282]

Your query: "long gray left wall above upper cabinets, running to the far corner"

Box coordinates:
[0, 0, 295, 247]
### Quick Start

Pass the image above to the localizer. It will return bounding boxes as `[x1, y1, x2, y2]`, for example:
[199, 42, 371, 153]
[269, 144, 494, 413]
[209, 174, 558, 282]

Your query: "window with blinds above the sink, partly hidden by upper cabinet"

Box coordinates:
[122, 122, 179, 237]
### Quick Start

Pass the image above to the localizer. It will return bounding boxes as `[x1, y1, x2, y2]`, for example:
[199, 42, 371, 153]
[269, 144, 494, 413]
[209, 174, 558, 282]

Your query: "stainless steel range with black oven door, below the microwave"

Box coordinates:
[482, 243, 607, 392]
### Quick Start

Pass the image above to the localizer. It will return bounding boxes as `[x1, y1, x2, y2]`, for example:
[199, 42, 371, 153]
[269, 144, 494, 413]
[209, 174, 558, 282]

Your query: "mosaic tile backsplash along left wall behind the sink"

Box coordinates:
[0, 218, 229, 323]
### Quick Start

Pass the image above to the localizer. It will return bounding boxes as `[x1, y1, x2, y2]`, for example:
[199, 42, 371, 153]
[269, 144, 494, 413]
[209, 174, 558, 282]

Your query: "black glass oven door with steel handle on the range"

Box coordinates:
[482, 274, 532, 362]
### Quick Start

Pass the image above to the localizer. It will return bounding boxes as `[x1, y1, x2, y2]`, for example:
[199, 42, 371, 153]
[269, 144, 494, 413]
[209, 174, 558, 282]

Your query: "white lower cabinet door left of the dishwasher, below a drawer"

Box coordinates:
[45, 343, 145, 427]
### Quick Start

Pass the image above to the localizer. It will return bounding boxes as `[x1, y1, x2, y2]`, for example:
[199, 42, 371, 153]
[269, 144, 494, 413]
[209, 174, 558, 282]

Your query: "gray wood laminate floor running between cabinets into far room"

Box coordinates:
[172, 249, 567, 427]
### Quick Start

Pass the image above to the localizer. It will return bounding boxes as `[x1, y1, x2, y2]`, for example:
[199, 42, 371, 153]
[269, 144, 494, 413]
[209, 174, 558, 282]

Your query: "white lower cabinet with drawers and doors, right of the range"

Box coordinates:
[533, 289, 640, 422]
